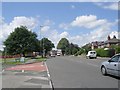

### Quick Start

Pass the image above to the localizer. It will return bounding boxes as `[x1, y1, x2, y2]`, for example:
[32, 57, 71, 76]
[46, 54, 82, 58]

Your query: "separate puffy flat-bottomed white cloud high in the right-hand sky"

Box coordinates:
[71, 15, 107, 29]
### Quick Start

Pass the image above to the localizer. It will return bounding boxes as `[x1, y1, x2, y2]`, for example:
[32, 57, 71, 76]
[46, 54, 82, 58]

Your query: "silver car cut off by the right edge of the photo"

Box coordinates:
[101, 54, 120, 77]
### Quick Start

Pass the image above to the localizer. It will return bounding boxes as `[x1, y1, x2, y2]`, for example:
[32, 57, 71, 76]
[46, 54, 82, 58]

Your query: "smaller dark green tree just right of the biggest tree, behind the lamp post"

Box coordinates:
[40, 38, 54, 56]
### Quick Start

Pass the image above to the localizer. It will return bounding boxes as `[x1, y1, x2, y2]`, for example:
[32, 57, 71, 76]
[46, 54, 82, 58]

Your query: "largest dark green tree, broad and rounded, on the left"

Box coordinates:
[4, 26, 39, 56]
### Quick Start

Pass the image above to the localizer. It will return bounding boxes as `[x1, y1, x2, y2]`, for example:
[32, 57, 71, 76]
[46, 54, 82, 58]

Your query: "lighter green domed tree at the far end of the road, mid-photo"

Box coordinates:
[57, 38, 69, 55]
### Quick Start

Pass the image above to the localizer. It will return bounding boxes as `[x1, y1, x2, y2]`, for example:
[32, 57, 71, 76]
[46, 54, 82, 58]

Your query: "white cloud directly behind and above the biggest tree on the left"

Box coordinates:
[0, 16, 38, 50]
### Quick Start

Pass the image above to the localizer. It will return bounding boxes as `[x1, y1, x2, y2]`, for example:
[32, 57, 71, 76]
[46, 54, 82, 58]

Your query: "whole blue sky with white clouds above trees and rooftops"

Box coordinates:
[0, 2, 119, 50]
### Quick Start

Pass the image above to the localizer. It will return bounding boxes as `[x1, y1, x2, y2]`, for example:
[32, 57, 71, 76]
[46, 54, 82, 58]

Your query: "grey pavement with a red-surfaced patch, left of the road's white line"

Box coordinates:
[2, 61, 52, 90]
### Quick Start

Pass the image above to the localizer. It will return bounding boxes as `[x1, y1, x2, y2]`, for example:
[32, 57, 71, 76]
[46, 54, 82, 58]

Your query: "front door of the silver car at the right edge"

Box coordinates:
[107, 55, 120, 76]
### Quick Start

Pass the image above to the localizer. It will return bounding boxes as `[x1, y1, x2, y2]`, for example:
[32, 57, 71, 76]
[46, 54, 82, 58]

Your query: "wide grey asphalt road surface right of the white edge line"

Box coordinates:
[47, 56, 118, 88]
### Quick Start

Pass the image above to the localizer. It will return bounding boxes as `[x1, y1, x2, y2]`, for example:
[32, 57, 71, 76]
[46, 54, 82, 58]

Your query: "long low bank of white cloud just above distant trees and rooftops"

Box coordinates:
[41, 25, 117, 47]
